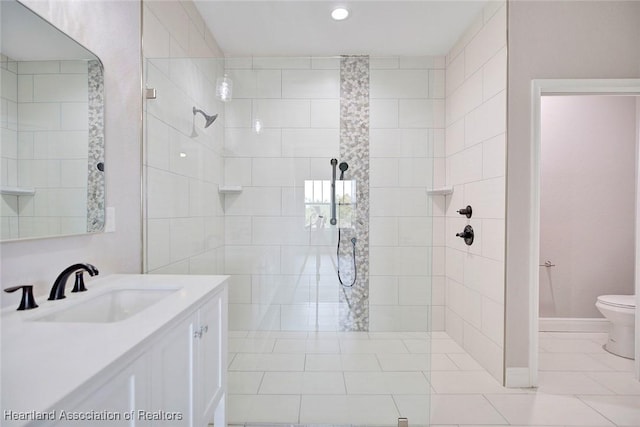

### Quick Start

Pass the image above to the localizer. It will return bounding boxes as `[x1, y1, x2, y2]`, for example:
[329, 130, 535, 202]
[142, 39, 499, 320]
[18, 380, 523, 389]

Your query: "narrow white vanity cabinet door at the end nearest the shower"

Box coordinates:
[195, 292, 227, 426]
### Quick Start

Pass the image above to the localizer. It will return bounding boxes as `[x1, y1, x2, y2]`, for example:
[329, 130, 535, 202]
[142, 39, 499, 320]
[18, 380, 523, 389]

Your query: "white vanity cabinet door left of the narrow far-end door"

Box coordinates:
[148, 318, 196, 427]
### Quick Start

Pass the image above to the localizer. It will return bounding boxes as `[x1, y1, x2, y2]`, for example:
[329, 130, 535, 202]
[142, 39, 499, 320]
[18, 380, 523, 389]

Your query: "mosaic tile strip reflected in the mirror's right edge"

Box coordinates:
[87, 60, 105, 233]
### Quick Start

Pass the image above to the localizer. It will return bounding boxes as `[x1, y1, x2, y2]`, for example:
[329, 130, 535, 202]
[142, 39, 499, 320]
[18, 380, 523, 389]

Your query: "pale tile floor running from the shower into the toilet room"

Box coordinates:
[227, 332, 640, 427]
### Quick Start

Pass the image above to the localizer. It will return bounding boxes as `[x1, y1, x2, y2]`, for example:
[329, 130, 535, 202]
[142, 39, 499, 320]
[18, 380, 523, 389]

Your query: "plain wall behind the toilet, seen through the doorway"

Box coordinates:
[540, 96, 636, 318]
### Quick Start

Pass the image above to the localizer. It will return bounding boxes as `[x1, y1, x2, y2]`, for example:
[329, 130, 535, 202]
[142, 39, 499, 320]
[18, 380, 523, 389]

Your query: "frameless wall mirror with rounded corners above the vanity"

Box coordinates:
[0, 0, 104, 241]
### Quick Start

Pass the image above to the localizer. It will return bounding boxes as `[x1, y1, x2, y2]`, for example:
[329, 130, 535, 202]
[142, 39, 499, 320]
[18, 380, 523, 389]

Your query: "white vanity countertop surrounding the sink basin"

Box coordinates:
[0, 274, 228, 425]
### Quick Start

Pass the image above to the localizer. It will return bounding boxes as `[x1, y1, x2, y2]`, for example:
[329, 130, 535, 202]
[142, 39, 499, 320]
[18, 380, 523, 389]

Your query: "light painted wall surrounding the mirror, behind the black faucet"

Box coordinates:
[0, 0, 141, 306]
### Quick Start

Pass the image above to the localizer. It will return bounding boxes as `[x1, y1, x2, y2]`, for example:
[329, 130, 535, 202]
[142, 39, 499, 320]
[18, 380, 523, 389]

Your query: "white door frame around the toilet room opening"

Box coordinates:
[529, 79, 640, 387]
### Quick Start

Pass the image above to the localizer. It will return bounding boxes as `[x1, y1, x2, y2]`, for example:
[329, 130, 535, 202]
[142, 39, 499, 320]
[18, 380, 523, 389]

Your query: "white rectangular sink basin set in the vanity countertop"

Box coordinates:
[33, 289, 177, 323]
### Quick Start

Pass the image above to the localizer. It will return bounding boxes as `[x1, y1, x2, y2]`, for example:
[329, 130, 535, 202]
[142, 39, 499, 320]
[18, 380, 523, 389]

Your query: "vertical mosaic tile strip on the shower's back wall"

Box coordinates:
[338, 56, 369, 331]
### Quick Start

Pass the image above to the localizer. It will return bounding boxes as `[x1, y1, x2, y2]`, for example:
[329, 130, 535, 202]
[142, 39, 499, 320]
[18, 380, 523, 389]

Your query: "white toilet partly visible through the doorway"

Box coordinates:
[596, 295, 636, 359]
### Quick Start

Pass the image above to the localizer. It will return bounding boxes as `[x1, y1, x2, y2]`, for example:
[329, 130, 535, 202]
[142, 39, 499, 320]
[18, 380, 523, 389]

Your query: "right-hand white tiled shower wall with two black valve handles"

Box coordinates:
[445, 2, 507, 381]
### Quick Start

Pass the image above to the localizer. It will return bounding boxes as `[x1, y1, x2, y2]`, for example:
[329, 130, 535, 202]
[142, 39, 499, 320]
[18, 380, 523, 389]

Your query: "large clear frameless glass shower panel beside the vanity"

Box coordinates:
[145, 51, 444, 425]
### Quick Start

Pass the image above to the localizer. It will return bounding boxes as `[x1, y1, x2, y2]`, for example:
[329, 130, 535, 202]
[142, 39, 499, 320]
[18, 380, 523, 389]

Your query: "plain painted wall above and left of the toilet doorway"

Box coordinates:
[506, 1, 640, 368]
